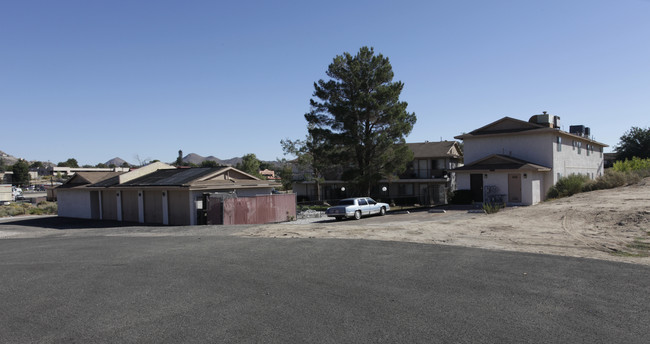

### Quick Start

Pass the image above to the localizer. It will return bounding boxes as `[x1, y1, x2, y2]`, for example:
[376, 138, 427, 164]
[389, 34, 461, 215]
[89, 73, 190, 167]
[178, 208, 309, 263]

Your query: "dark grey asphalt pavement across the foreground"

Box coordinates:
[0, 218, 650, 343]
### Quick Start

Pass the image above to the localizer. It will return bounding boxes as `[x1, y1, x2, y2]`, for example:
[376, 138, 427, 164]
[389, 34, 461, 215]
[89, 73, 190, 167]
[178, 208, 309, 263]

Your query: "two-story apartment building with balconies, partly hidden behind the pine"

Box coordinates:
[293, 141, 463, 204]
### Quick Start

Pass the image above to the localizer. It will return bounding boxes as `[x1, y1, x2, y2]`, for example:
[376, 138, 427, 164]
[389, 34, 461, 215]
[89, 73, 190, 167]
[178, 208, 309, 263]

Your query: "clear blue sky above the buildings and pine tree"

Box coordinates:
[0, 0, 650, 165]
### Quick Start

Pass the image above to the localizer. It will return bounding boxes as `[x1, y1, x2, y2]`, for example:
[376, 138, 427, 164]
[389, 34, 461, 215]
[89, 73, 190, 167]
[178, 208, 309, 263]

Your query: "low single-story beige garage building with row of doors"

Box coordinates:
[57, 162, 295, 226]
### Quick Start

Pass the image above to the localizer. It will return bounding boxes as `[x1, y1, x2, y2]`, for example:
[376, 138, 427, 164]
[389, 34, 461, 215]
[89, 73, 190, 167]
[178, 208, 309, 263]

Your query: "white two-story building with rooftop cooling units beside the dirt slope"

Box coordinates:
[454, 112, 607, 205]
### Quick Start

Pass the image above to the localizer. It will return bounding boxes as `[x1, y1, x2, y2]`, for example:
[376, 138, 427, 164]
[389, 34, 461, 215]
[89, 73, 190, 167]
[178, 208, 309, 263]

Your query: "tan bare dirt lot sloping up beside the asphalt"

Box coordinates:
[238, 178, 650, 265]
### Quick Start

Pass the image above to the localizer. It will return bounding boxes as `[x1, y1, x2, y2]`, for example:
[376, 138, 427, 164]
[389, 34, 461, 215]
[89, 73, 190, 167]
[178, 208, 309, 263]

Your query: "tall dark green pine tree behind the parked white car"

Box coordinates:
[305, 47, 416, 195]
